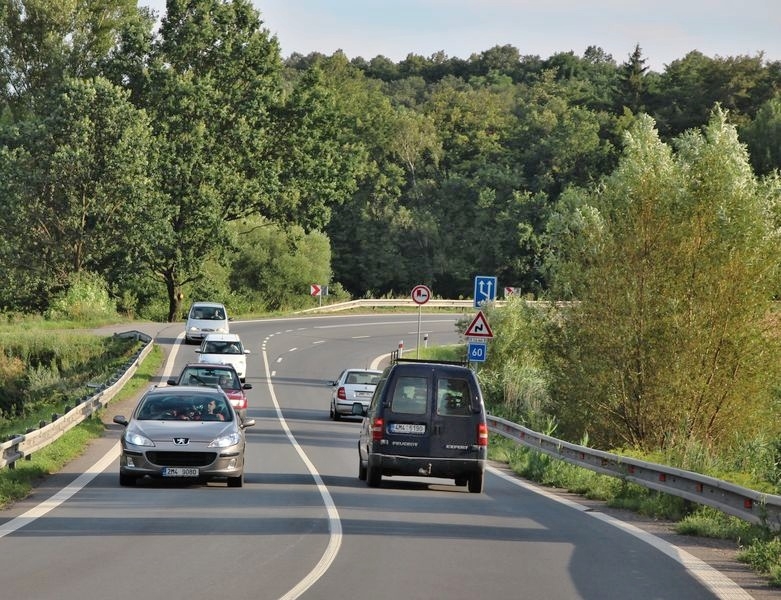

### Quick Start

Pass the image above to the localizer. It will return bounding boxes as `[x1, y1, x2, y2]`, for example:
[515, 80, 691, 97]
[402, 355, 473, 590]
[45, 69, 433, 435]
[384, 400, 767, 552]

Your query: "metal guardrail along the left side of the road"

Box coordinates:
[0, 331, 153, 469]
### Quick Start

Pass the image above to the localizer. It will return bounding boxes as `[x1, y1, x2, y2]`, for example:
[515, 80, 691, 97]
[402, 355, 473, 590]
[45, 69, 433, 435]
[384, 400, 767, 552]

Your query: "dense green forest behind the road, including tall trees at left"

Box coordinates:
[0, 0, 781, 319]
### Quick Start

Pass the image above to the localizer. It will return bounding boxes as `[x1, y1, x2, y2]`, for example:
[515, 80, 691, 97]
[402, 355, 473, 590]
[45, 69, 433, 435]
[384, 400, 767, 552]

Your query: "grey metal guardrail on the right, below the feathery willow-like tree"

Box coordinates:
[488, 415, 781, 531]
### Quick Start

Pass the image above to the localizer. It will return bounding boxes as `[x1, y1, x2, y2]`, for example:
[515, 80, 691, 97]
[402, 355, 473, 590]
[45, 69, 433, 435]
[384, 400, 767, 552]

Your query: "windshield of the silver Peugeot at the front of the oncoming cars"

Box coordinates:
[136, 394, 233, 421]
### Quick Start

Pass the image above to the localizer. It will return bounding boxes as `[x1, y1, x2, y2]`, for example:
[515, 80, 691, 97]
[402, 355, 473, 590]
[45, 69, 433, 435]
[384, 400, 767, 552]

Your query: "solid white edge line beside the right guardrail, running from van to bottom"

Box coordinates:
[487, 467, 752, 600]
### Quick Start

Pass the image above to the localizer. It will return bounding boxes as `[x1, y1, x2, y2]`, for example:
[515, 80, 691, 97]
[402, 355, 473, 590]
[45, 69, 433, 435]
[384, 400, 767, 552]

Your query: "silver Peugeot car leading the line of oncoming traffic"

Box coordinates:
[114, 385, 255, 487]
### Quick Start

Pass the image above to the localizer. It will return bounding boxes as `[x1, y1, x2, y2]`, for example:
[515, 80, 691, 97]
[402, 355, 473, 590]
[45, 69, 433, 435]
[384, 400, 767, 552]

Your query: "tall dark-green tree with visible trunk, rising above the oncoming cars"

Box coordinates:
[131, 0, 360, 320]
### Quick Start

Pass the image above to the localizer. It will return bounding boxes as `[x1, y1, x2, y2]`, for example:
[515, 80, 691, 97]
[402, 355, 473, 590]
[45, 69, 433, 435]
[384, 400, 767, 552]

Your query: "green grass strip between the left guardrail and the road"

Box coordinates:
[0, 346, 163, 508]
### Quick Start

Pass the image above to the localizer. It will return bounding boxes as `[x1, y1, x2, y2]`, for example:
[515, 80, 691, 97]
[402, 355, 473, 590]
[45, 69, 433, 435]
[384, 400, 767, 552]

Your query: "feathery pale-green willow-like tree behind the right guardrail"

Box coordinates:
[547, 110, 781, 449]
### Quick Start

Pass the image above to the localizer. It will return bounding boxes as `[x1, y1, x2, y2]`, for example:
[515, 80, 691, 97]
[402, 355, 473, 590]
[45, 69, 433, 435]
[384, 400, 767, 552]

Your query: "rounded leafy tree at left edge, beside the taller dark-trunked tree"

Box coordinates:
[0, 78, 156, 309]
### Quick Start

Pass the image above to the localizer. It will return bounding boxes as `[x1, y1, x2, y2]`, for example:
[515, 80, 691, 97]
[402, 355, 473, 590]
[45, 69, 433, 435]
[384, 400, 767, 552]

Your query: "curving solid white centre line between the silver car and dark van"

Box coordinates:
[263, 340, 342, 600]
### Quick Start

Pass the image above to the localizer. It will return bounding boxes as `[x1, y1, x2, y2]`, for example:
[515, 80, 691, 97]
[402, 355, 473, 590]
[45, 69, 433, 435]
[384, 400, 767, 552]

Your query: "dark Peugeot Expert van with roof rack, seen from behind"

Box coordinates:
[354, 359, 488, 494]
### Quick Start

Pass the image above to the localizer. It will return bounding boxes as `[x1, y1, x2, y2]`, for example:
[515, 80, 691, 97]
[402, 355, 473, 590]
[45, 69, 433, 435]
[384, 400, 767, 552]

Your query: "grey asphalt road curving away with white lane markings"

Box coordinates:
[0, 314, 750, 600]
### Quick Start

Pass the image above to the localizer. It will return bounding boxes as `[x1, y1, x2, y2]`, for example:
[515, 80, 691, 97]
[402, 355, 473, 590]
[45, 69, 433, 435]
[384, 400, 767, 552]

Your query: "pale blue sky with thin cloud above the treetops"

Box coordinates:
[139, 0, 781, 72]
